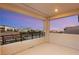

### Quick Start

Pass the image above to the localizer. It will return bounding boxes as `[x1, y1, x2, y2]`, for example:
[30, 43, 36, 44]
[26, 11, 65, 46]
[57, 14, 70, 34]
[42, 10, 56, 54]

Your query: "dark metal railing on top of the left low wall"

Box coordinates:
[0, 32, 45, 45]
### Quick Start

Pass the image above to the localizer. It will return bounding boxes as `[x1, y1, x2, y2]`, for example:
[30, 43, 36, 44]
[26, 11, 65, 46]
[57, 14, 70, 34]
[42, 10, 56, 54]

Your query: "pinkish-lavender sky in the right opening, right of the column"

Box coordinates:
[50, 15, 79, 30]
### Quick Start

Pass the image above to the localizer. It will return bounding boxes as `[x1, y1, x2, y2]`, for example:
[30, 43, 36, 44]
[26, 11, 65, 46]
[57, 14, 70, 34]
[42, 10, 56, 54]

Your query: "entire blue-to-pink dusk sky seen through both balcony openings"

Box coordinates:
[0, 9, 79, 30]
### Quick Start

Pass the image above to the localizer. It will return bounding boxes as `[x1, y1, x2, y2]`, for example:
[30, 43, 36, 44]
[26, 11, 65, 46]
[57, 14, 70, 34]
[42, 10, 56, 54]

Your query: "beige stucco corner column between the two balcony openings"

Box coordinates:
[44, 18, 50, 41]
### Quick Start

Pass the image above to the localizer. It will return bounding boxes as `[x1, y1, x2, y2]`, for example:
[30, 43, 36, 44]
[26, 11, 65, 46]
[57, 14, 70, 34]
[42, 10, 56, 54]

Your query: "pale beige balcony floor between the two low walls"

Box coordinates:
[16, 43, 79, 55]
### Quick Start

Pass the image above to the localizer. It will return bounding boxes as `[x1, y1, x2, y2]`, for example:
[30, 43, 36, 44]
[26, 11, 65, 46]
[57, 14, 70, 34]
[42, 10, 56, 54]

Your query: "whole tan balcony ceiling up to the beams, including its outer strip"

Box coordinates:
[0, 3, 79, 17]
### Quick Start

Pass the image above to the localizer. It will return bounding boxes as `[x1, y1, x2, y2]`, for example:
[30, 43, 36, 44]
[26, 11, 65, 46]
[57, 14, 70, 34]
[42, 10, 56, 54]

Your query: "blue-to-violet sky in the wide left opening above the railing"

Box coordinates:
[0, 9, 43, 30]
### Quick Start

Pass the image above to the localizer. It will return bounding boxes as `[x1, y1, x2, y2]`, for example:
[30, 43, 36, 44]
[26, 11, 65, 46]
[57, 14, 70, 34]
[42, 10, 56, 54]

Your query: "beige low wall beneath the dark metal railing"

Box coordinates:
[2, 38, 45, 54]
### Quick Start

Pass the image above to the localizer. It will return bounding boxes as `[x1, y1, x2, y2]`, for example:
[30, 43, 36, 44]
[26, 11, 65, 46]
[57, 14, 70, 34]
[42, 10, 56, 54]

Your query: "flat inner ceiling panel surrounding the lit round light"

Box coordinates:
[24, 3, 79, 16]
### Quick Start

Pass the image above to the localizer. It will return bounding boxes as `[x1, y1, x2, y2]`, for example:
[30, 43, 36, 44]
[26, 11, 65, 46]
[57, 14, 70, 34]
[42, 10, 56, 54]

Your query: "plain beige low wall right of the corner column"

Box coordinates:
[49, 33, 79, 49]
